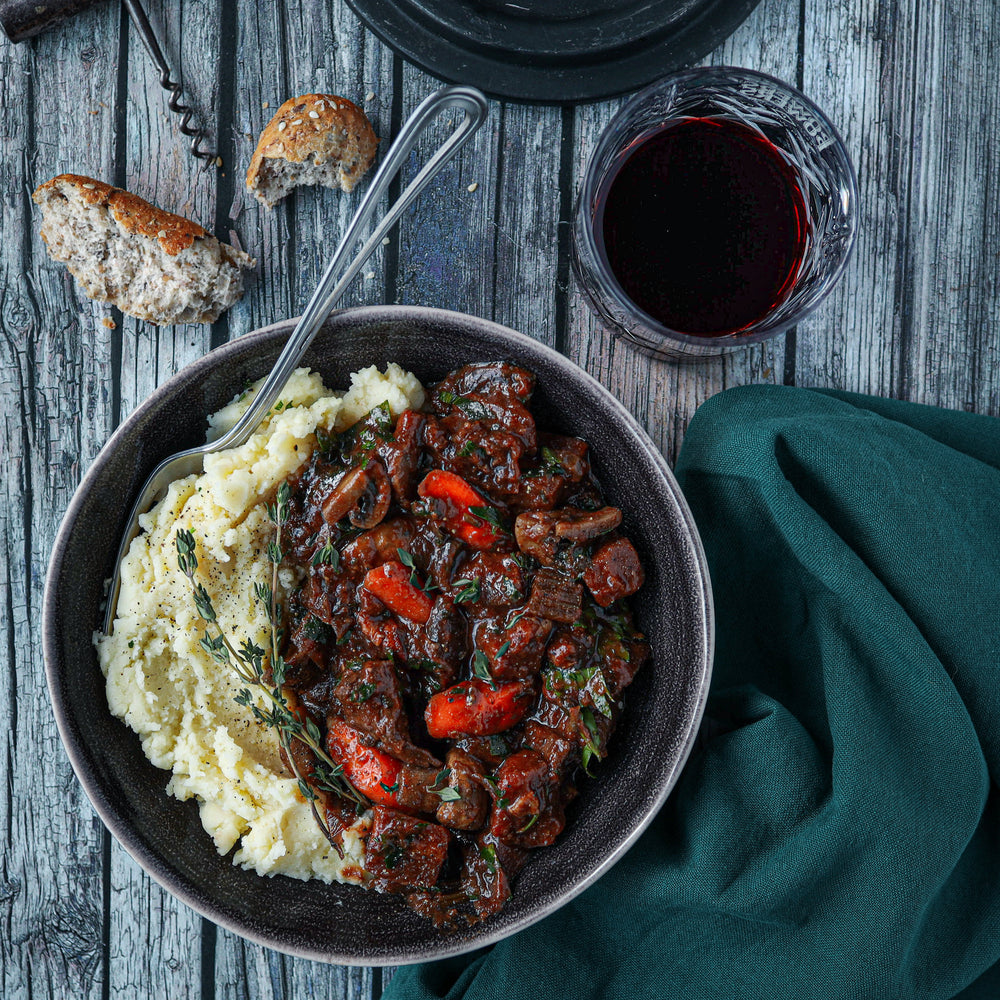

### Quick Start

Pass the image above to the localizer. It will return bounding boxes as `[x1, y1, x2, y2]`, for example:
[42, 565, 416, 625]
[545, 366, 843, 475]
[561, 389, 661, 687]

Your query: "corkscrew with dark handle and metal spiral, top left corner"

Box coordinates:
[0, 0, 216, 166]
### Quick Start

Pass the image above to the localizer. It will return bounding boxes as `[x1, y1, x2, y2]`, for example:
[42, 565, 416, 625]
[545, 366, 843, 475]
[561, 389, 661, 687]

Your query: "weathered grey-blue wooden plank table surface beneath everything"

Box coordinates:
[0, 0, 1000, 1000]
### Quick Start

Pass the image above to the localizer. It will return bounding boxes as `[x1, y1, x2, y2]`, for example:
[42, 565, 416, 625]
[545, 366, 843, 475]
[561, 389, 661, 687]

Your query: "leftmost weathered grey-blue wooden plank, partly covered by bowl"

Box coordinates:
[0, 3, 118, 997]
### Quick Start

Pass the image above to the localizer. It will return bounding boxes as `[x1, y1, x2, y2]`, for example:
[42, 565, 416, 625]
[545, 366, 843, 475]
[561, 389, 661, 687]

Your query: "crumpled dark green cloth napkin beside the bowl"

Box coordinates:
[385, 386, 1000, 1000]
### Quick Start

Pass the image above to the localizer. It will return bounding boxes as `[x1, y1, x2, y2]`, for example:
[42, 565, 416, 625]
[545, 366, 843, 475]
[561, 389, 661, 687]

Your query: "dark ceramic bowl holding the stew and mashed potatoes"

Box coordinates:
[43, 306, 713, 965]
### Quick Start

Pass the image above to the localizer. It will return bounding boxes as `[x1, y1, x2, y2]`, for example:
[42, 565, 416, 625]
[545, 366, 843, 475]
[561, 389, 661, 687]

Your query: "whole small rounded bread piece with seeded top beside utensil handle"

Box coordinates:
[247, 94, 378, 208]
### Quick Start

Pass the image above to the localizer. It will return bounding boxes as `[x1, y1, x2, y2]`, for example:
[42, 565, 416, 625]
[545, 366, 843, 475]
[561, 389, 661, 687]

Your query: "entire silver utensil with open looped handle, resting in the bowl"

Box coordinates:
[104, 86, 489, 635]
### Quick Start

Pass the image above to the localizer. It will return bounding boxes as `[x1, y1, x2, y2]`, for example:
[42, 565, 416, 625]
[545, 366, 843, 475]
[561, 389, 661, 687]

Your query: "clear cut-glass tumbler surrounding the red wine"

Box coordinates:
[573, 67, 858, 360]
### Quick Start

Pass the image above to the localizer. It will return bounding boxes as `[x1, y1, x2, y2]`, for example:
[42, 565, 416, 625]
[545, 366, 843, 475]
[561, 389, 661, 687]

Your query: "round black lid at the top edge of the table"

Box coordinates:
[348, 0, 759, 104]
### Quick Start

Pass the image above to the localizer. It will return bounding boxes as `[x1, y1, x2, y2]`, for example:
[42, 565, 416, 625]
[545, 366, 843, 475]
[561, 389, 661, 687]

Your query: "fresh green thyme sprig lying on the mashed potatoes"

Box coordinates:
[176, 496, 369, 846]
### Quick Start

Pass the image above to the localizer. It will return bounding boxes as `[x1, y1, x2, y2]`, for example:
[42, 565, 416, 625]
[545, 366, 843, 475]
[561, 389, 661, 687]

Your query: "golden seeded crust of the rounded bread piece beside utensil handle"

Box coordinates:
[247, 94, 378, 204]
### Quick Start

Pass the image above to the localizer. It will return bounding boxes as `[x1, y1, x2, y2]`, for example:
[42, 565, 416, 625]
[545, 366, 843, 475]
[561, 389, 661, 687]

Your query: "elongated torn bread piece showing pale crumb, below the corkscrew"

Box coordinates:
[32, 174, 257, 324]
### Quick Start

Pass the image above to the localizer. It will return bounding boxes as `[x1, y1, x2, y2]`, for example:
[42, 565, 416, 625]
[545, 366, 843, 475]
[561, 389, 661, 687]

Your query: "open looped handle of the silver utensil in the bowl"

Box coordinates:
[211, 86, 488, 451]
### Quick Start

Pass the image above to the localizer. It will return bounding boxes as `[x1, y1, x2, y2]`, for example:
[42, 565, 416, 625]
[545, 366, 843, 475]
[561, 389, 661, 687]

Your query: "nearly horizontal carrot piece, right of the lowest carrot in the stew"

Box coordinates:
[424, 678, 534, 740]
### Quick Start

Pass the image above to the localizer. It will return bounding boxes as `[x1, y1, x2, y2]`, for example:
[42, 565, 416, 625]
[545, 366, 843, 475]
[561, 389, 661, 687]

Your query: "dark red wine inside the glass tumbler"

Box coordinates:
[595, 118, 808, 336]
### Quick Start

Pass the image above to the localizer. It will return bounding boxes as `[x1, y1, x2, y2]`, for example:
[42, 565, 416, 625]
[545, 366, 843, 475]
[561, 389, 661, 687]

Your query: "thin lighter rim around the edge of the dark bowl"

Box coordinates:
[42, 305, 715, 966]
